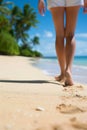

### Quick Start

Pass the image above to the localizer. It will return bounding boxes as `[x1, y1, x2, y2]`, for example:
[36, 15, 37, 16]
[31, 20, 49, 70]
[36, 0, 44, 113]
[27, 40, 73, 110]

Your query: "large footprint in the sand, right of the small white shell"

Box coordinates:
[56, 104, 85, 114]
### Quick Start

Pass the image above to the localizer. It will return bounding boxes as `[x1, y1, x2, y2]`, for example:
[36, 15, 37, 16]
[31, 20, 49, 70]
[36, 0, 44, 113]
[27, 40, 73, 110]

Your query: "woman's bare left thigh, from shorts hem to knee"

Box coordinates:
[50, 7, 65, 36]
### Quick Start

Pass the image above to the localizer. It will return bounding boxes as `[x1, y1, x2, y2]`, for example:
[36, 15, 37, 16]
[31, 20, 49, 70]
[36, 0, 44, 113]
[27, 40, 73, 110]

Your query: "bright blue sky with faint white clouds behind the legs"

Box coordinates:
[7, 0, 87, 56]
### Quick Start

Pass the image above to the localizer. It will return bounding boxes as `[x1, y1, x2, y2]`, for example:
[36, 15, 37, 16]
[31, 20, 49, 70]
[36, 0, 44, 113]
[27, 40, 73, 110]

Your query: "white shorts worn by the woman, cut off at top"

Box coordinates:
[47, 0, 84, 9]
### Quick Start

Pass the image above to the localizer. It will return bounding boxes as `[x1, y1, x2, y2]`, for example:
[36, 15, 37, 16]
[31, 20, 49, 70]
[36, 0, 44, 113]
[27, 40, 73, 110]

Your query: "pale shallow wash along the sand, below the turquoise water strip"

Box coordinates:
[33, 58, 87, 85]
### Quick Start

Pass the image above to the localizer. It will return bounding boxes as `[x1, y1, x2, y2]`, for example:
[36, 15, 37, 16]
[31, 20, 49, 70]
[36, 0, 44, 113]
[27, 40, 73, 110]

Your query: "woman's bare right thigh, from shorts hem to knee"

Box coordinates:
[65, 6, 80, 36]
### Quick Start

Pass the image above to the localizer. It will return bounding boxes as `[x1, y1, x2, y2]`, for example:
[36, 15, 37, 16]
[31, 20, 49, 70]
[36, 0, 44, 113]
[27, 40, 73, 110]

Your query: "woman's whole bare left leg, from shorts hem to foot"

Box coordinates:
[50, 7, 65, 81]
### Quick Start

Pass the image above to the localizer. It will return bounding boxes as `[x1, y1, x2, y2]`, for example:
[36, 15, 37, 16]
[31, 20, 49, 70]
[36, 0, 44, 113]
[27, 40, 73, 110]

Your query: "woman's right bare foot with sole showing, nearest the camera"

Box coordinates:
[65, 71, 74, 86]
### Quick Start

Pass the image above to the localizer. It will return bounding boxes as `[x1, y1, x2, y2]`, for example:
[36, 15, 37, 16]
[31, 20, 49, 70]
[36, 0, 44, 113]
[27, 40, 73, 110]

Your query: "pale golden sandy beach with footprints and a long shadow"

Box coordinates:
[0, 56, 87, 130]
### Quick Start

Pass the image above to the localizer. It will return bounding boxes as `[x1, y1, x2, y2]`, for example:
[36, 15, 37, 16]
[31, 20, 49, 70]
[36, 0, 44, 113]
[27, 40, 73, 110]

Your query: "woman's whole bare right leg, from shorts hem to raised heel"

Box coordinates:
[65, 6, 80, 85]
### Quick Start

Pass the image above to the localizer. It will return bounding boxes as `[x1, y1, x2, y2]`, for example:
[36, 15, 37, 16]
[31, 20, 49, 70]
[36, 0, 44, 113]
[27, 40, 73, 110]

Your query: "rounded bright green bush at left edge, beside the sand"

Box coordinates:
[0, 31, 19, 55]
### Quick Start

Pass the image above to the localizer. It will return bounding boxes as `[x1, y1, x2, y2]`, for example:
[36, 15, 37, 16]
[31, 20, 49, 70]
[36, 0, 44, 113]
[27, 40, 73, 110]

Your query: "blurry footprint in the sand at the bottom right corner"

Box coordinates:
[70, 118, 87, 130]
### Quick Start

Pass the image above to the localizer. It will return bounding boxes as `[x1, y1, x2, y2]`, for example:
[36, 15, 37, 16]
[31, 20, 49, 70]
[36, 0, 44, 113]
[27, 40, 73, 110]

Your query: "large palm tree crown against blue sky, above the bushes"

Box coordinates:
[11, 4, 38, 44]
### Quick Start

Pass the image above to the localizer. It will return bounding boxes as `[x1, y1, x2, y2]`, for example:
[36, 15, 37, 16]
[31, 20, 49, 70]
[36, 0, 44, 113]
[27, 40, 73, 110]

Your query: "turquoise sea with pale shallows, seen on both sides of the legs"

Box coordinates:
[33, 56, 87, 85]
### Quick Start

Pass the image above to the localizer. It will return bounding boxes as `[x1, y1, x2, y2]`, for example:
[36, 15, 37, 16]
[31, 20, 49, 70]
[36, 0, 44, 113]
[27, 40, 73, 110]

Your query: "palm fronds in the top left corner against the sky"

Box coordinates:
[0, 0, 13, 15]
